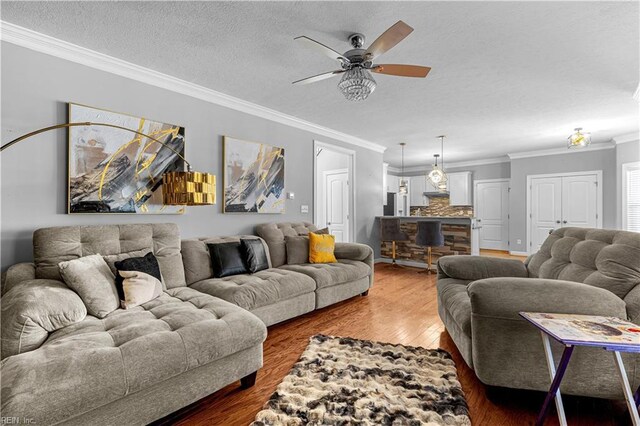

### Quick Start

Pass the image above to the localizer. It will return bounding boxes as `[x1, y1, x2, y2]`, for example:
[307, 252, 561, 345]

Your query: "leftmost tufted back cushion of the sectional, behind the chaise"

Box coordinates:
[33, 223, 187, 288]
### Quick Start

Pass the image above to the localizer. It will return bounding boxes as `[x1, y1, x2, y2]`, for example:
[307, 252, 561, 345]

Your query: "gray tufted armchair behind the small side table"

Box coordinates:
[437, 228, 640, 398]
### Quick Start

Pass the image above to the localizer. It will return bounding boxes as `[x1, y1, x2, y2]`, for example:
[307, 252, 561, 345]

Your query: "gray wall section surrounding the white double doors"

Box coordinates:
[509, 149, 616, 252]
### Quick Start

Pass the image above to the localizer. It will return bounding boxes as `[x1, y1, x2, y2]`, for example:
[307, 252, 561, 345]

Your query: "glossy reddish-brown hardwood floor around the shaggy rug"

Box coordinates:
[162, 264, 630, 426]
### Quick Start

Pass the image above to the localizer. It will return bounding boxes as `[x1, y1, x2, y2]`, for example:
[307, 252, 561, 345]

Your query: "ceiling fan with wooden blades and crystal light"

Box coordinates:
[293, 21, 431, 101]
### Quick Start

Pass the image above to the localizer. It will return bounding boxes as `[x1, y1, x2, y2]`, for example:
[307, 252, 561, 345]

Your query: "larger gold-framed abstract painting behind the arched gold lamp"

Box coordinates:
[69, 103, 185, 214]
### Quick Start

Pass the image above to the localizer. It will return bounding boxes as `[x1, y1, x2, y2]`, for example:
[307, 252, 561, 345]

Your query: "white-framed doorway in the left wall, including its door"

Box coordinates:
[313, 141, 356, 242]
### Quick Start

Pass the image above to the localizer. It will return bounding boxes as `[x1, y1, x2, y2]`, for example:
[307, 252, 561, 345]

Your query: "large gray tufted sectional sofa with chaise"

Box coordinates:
[0, 223, 373, 425]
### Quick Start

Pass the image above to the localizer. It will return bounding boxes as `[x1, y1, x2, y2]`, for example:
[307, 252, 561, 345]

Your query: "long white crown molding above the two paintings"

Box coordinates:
[0, 21, 387, 153]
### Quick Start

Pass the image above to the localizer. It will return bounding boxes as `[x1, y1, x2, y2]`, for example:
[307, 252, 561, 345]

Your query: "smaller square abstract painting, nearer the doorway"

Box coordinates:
[223, 136, 285, 213]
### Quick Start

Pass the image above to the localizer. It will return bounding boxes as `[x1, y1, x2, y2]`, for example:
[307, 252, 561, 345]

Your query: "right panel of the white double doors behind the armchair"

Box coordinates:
[562, 175, 598, 228]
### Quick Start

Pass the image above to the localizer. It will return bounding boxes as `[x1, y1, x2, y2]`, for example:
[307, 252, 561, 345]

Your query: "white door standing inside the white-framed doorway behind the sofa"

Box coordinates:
[324, 170, 349, 242]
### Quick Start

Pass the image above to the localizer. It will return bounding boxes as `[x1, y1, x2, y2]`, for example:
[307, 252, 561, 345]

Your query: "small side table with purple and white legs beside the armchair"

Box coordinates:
[520, 312, 640, 426]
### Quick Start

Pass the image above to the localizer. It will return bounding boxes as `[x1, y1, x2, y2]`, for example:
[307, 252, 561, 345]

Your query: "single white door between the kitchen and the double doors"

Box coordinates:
[475, 181, 509, 250]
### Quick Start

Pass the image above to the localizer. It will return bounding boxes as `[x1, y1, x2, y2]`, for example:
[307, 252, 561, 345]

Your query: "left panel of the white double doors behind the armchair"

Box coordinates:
[529, 177, 562, 253]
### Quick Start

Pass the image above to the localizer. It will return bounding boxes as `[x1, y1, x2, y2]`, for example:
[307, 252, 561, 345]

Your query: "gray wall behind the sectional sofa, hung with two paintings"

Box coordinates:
[0, 43, 382, 269]
